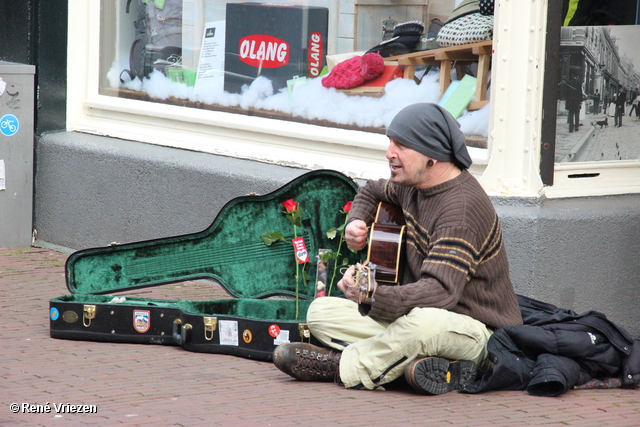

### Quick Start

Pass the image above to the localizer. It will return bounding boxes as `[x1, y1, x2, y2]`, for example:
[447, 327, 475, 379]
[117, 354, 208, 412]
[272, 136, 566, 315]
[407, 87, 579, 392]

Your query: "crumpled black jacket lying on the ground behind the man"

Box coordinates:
[465, 295, 640, 396]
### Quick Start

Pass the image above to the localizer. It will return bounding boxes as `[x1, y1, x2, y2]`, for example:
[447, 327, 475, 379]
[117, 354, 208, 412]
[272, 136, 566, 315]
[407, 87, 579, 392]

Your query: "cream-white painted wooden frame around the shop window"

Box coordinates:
[67, 0, 640, 197]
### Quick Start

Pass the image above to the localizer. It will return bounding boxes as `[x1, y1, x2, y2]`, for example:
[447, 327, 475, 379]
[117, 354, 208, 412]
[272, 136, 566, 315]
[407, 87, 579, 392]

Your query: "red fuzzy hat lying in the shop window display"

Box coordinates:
[322, 53, 384, 89]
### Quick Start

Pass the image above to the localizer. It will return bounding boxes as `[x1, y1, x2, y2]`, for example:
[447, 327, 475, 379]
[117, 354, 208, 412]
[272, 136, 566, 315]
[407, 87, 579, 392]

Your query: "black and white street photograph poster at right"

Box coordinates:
[555, 25, 640, 162]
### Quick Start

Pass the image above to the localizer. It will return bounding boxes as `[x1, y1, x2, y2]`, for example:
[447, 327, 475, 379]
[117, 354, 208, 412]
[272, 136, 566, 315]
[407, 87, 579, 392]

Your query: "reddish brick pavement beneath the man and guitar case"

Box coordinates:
[0, 248, 640, 427]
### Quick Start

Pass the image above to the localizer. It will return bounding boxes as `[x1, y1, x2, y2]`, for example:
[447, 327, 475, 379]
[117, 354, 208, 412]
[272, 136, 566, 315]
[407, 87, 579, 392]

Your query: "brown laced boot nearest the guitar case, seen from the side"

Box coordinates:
[273, 343, 341, 381]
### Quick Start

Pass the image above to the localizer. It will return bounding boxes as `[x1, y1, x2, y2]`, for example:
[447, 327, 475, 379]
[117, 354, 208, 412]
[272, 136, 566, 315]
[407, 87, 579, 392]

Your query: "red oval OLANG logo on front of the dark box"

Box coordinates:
[240, 34, 289, 68]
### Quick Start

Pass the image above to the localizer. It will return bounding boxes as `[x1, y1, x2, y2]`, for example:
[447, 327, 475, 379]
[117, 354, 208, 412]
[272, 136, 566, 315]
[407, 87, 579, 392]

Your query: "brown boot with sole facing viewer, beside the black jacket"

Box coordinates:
[404, 357, 477, 394]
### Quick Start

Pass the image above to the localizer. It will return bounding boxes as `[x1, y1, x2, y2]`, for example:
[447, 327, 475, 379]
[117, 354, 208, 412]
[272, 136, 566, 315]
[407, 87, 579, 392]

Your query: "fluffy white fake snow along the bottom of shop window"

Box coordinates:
[108, 66, 489, 136]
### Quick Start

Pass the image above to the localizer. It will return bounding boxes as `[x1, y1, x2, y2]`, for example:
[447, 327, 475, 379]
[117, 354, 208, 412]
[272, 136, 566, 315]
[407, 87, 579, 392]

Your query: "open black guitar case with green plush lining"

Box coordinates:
[49, 170, 363, 360]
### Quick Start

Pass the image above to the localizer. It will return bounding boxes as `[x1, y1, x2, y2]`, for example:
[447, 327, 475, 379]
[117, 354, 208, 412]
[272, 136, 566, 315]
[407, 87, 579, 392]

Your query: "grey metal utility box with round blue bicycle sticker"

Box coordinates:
[0, 61, 35, 248]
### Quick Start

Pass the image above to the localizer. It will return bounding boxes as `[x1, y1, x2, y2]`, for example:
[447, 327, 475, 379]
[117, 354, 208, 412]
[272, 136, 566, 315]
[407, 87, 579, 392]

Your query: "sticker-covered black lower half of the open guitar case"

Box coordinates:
[49, 295, 317, 361]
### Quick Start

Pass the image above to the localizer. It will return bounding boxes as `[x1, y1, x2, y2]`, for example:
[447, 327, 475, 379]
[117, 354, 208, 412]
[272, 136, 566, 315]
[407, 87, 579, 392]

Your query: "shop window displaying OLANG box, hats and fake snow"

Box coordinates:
[99, 0, 490, 144]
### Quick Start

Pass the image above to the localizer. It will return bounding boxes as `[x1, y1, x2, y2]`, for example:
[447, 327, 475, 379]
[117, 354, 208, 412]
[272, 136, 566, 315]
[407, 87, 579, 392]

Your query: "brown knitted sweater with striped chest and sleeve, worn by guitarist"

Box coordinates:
[349, 170, 522, 329]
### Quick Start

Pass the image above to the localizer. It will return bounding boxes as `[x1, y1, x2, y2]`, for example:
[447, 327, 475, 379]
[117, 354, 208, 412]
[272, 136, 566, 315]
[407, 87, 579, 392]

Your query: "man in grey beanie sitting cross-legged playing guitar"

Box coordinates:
[273, 103, 522, 394]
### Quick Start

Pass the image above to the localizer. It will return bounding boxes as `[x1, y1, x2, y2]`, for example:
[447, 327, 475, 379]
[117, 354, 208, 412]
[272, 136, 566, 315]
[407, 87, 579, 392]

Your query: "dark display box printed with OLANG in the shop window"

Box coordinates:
[224, 3, 329, 93]
